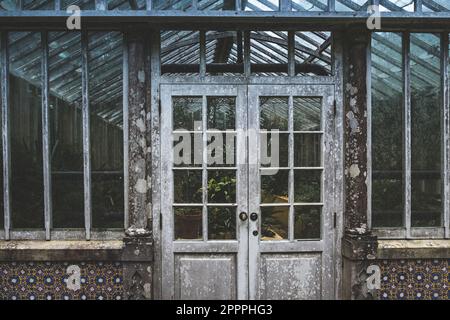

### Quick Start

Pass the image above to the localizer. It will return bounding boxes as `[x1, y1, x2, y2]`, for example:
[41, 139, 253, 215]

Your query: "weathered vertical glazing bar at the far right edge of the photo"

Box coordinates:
[441, 33, 450, 238]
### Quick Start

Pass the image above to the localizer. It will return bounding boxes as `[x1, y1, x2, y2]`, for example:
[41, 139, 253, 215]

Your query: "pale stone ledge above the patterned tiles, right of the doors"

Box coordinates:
[377, 240, 450, 259]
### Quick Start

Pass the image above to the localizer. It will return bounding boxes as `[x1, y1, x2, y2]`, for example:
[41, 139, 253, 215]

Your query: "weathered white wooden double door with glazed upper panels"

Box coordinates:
[161, 85, 335, 300]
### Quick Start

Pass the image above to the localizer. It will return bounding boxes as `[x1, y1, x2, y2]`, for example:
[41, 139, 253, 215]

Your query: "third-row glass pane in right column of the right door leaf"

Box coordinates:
[294, 170, 322, 202]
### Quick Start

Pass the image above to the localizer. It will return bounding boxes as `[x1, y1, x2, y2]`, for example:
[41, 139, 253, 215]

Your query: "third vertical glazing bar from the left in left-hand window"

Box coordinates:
[81, 30, 92, 240]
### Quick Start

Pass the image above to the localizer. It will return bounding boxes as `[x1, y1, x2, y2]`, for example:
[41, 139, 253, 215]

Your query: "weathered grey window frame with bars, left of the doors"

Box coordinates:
[0, 29, 128, 241]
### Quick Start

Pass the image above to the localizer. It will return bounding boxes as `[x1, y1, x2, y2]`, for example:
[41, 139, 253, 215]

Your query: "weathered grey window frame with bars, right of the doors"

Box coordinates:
[367, 31, 450, 239]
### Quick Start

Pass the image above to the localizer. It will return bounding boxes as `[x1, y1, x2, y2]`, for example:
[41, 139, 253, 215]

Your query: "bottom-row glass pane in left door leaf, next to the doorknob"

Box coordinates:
[208, 207, 236, 240]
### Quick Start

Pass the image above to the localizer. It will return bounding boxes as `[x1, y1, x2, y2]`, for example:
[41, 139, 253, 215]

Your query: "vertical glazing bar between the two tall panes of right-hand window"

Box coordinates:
[402, 32, 411, 238]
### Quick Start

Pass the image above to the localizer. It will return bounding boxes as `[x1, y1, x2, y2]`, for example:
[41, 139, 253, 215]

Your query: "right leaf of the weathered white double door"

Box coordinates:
[248, 85, 334, 299]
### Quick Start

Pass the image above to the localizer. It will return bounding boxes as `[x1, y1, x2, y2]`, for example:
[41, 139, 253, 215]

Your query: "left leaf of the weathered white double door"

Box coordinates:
[161, 85, 248, 299]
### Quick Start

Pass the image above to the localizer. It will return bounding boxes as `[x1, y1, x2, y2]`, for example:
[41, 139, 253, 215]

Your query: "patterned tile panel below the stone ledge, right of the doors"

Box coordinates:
[377, 259, 450, 300]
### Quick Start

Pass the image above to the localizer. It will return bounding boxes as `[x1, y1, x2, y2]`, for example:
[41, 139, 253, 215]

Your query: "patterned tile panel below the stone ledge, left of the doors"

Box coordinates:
[0, 262, 123, 300]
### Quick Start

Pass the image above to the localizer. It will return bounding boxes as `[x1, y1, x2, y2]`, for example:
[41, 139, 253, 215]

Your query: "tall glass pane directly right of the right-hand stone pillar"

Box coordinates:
[371, 32, 404, 227]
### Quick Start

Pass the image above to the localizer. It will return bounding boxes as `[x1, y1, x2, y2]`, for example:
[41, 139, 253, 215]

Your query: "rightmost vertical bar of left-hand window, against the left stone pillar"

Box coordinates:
[122, 32, 130, 230]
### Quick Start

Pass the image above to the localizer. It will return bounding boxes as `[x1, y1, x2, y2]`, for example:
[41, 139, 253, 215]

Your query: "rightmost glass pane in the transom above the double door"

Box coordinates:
[294, 31, 333, 76]
